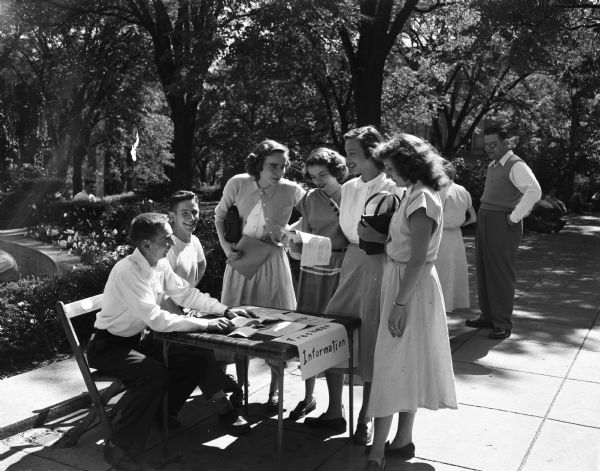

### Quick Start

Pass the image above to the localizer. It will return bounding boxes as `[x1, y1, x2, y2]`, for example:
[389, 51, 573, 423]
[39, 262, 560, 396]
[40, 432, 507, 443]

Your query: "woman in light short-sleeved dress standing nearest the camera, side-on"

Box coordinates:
[365, 134, 457, 471]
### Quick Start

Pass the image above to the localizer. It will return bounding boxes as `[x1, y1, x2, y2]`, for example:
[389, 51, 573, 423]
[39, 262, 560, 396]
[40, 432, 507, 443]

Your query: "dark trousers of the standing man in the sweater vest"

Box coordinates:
[475, 209, 523, 329]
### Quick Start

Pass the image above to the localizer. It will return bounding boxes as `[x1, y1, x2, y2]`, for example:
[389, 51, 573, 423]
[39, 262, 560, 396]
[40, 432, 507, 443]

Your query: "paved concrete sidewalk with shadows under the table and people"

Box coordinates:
[0, 216, 600, 471]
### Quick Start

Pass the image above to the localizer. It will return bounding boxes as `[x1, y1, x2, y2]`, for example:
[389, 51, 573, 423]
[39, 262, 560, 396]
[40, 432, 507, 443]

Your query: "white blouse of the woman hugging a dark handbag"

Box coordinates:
[340, 172, 404, 244]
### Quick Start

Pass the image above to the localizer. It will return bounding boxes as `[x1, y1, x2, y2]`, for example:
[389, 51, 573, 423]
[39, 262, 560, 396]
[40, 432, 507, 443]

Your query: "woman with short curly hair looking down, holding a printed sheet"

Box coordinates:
[290, 147, 348, 420]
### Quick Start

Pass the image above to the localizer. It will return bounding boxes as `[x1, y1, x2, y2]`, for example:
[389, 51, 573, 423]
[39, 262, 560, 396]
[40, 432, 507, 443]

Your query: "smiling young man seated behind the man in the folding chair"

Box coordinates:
[167, 190, 206, 288]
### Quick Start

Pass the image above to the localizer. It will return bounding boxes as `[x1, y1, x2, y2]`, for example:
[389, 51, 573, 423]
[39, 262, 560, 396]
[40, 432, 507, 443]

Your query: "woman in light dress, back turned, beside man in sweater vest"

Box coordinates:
[435, 162, 477, 312]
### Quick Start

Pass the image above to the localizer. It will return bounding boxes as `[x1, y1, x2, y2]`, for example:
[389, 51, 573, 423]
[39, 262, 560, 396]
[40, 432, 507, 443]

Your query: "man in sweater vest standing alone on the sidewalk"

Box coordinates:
[466, 125, 542, 339]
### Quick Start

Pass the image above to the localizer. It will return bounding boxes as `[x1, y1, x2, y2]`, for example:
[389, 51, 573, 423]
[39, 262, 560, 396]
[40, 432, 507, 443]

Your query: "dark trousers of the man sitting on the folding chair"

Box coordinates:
[87, 330, 225, 449]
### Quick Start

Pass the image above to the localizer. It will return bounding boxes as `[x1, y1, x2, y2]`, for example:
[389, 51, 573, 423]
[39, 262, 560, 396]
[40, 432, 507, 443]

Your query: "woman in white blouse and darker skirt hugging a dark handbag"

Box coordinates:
[305, 126, 404, 445]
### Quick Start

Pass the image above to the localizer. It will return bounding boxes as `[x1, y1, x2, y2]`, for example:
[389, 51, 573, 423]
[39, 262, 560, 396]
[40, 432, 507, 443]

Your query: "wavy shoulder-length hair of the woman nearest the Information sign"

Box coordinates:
[377, 133, 448, 191]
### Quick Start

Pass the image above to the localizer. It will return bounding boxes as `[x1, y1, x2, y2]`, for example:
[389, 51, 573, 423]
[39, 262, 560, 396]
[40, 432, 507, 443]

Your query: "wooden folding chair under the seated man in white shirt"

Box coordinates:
[56, 294, 124, 447]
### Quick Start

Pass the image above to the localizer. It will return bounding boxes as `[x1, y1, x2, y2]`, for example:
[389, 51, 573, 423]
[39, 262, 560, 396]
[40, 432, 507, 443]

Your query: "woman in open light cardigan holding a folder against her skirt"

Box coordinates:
[215, 139, 304, 410]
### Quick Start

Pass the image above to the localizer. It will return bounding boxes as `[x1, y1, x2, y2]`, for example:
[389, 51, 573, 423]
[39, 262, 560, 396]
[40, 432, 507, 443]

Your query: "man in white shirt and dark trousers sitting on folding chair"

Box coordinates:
[87, 213, 250, 469]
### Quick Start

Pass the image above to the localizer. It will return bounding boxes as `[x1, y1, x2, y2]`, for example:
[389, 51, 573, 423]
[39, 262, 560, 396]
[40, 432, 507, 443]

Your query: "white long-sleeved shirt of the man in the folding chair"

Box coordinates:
[94, 249, 227, 337]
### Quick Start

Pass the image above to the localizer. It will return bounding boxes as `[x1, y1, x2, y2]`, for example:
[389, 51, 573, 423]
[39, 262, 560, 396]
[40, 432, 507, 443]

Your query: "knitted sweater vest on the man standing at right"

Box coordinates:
[480, 154, 523, 212]
